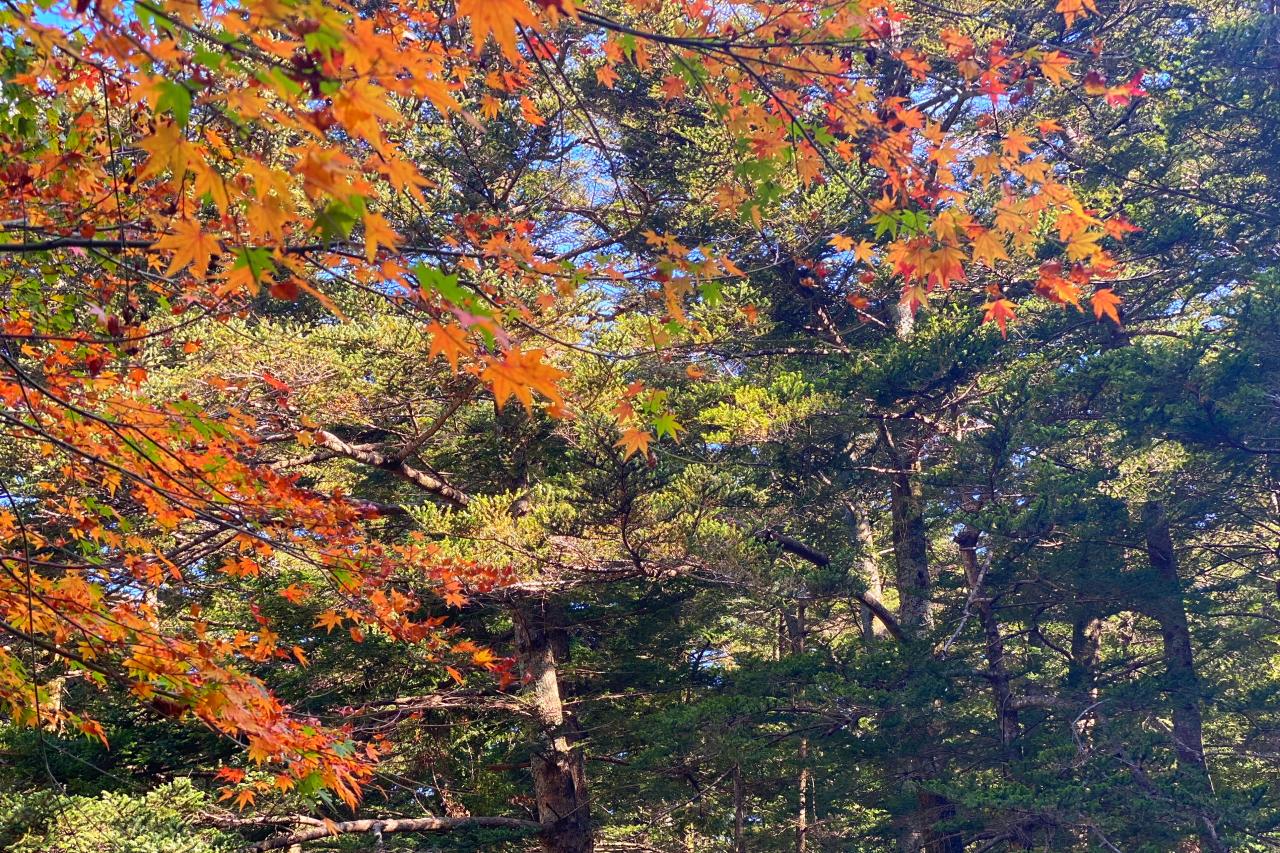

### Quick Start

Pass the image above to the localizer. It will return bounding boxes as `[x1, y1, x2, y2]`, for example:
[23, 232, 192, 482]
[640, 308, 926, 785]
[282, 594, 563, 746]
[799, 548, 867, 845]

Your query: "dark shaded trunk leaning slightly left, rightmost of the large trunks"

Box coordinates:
[1142, 501, 1229, 852]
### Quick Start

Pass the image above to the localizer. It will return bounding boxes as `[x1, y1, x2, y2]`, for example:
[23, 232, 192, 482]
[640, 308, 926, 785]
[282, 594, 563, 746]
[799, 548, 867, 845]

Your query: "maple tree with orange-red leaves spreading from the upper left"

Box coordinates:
[0, 0, 1269, 849]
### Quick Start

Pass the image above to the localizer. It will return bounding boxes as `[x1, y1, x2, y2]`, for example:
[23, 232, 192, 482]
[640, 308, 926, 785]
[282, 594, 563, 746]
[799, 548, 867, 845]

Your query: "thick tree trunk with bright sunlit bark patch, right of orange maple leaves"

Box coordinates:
[512, 601, 595, 853]
